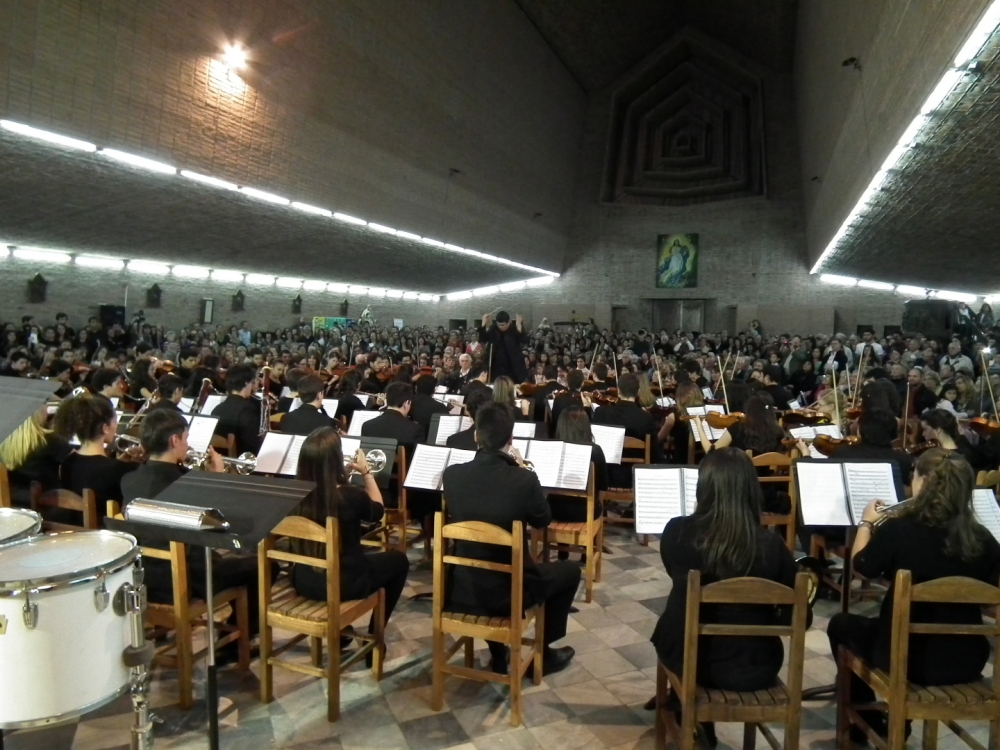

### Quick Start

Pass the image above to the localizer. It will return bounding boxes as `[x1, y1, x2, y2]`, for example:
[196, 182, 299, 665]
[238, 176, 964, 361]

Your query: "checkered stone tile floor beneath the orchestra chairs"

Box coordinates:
[0, 531, 986, 750]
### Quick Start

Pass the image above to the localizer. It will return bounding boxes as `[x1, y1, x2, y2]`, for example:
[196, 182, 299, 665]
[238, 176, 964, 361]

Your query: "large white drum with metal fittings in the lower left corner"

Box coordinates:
[0, 531, 139, 729]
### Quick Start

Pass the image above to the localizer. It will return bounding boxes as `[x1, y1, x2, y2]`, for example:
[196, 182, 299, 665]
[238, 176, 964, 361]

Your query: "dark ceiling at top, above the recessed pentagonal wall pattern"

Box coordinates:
[517, 0, 798, 91]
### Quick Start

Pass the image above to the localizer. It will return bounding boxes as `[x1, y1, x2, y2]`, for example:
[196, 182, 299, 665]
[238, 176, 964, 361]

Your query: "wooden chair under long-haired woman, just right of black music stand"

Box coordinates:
[258, 516, 385, 721]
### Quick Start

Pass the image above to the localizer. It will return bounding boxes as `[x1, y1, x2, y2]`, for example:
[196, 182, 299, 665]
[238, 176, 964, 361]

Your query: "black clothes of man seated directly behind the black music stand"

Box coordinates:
[121, 461, 268, 635]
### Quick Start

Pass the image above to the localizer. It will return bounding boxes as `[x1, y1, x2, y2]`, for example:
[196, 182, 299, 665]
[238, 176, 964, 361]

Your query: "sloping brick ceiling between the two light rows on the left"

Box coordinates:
[0, 130, 538, 293]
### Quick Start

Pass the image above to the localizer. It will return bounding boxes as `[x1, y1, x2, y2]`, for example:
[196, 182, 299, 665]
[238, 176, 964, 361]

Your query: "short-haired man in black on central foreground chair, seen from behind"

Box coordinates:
[443, 404, 580, 675]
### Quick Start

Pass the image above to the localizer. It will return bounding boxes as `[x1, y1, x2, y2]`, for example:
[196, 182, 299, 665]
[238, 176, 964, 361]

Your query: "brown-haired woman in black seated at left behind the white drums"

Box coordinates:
[53, 393, 139, 526]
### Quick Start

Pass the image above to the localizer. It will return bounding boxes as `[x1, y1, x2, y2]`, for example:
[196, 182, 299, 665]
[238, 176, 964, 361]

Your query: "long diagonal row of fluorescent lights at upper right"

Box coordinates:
[809, 8, 1000, 276]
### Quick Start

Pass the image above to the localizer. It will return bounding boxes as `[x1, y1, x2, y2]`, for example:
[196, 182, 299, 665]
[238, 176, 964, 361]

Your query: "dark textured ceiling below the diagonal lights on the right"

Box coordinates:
[823, 38, 1000, 293]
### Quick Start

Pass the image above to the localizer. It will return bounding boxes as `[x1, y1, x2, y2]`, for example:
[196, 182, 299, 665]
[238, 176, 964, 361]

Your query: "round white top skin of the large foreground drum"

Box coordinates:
[0, 530, 139, 595]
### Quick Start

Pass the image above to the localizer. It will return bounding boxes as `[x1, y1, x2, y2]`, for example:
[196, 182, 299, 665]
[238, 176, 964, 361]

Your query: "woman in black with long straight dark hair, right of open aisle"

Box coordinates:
[647, 447, 798, 742]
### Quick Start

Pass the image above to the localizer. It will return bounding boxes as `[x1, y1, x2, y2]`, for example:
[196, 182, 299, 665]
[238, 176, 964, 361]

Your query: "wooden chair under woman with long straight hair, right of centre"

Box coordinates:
[656, 570, 809, 750]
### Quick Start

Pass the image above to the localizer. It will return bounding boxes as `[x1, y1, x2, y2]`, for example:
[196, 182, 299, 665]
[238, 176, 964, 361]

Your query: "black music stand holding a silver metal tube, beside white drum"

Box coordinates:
[104, 471, 316, 750]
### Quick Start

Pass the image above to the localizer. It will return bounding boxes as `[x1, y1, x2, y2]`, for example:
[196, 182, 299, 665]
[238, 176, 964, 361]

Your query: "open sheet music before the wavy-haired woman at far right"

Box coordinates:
[792, 458, 898, 526]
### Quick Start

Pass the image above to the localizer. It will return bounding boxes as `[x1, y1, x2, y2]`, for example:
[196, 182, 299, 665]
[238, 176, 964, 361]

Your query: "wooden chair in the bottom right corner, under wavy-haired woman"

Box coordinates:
[837, 570, 1000, 750]
